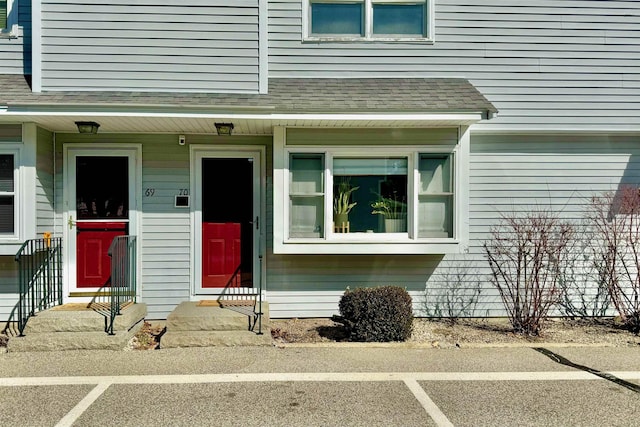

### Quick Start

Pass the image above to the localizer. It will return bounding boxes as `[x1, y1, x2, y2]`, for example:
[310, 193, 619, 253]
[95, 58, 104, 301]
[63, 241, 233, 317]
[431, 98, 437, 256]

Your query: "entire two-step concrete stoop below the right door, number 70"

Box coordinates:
[160, 301, 272, 348]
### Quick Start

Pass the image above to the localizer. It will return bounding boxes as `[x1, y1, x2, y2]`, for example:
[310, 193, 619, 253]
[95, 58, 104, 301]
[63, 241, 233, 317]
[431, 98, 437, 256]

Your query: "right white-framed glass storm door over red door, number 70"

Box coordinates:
[194, 152, 261, 294]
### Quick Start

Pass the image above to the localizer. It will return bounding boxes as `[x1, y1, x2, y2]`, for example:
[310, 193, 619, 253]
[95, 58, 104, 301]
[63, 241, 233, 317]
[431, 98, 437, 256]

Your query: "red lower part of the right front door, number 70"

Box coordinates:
[202, 222, 242, 288]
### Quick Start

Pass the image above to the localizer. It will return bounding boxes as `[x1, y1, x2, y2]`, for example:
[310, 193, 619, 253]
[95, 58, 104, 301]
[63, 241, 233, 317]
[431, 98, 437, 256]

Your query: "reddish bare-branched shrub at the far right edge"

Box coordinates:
[585, 186, 640, 334]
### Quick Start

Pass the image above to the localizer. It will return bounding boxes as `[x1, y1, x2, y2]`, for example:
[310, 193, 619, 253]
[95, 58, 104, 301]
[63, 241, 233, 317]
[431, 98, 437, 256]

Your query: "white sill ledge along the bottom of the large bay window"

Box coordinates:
[273, 238, 466, 255]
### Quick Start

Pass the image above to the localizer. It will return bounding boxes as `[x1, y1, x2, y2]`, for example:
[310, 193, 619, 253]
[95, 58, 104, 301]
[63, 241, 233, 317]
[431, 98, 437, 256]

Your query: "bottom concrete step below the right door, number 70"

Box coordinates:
[160, 328, 273, 349]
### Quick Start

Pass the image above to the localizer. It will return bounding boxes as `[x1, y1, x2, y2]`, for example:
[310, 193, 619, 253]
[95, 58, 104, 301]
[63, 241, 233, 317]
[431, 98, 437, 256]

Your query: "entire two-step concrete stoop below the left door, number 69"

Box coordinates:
[7, 304, 147, 352]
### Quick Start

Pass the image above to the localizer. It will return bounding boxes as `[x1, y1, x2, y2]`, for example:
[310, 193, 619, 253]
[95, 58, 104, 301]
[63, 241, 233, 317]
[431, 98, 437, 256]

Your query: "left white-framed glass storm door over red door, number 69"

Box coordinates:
[65, 148, 136, 292]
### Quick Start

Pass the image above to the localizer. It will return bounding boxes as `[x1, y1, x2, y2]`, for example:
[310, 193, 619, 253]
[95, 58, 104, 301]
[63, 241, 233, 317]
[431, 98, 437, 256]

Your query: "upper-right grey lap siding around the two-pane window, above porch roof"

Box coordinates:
[269, 0, 640, 129]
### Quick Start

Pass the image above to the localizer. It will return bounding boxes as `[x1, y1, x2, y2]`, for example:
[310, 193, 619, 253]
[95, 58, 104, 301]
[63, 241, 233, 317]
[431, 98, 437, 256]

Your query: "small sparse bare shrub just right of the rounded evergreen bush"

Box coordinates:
[423, 260, 482, 323]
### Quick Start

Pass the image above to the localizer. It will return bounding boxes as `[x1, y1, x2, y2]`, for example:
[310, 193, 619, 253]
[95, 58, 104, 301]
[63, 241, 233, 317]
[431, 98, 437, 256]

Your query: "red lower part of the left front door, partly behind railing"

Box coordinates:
[76, 221, 127, 288]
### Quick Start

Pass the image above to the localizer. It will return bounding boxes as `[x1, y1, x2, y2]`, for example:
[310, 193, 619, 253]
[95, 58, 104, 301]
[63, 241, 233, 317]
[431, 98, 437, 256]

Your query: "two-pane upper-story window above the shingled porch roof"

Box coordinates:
[306, 0, 433, 41]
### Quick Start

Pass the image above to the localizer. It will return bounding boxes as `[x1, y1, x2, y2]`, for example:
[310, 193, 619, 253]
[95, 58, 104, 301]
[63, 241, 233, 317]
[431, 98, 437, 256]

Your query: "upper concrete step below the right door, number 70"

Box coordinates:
[163, 301, 268, 334]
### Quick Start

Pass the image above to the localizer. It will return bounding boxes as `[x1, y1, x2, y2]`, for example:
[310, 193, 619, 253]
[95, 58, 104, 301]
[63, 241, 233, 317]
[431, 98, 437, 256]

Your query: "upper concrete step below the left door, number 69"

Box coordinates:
[24, 304, 147, 336]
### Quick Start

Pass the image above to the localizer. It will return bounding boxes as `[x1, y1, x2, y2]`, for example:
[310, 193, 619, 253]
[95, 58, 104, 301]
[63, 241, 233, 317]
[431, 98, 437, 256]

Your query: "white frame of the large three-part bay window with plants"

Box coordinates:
[273, 128, 468, 254]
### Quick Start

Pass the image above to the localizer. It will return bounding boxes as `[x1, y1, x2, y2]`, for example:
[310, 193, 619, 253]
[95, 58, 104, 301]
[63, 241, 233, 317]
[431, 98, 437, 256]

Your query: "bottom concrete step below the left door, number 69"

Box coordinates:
[7, 321, 144, 352]
